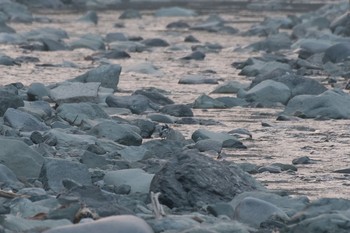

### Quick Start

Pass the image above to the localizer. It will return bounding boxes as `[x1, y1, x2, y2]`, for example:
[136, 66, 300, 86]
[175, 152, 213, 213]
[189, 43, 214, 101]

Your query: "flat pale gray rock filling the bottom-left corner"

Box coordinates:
[0, 214, 72, 232]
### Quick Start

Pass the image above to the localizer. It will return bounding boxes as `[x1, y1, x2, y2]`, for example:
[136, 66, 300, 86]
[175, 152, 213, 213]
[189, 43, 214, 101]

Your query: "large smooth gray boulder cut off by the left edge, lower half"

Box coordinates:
[0, 139, 44, 178]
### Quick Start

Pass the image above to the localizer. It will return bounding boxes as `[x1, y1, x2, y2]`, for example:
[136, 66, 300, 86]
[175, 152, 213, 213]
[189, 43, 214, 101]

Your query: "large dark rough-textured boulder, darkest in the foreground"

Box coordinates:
[151, 150, 263, 208]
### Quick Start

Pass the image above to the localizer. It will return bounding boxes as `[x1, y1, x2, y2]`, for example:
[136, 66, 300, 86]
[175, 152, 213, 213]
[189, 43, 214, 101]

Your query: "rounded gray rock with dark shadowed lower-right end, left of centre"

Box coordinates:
[89, 121, 142, 146]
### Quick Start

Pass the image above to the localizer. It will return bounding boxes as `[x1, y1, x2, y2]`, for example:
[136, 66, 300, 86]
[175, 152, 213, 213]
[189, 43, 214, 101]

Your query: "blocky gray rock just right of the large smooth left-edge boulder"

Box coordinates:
[39, 158, 91, 193]
